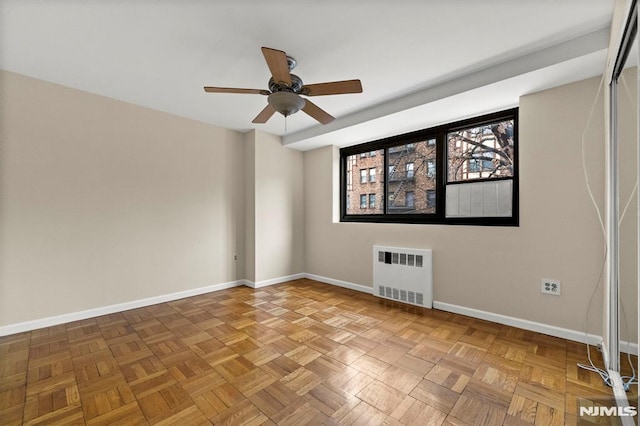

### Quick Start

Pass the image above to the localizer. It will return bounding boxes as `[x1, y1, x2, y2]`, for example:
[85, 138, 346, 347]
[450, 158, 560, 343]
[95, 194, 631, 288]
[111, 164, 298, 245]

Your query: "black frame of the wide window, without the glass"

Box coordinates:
[340, 108, 520, 227]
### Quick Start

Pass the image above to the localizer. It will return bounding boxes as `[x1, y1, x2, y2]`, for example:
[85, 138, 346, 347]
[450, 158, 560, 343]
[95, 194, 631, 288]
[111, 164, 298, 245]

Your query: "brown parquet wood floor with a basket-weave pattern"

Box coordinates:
[0, 279, 637, 426]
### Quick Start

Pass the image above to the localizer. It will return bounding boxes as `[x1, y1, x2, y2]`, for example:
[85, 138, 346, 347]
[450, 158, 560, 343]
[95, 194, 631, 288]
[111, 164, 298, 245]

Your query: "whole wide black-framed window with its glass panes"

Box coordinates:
[340, 108, 519, 226]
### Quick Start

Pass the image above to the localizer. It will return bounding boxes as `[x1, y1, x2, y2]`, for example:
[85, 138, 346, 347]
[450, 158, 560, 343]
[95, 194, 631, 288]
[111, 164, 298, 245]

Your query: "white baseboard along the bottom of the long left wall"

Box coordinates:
[0, 280, 244, 336]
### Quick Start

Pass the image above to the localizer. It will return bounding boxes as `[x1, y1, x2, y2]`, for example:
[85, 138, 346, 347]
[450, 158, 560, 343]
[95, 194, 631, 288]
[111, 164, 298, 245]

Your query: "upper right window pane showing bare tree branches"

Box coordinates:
[447, 120, 514, 182]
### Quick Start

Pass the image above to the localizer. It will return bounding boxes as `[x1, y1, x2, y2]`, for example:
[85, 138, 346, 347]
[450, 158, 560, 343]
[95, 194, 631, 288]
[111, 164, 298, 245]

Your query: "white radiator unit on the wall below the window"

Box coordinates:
[373, 246, 433, 308]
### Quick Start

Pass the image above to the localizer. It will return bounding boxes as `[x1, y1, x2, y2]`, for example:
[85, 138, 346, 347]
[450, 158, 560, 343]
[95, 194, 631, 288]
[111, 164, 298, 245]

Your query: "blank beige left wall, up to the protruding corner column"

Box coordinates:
[0, 72, 245, 326]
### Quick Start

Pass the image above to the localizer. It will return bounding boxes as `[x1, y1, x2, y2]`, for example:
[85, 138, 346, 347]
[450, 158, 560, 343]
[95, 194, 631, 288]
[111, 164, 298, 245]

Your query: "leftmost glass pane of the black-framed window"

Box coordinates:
[345, 150, 384, 215]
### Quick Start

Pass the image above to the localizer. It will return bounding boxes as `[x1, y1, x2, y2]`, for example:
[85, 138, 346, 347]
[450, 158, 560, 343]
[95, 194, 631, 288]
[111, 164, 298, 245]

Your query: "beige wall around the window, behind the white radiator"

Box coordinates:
[304, 75, 624, 334]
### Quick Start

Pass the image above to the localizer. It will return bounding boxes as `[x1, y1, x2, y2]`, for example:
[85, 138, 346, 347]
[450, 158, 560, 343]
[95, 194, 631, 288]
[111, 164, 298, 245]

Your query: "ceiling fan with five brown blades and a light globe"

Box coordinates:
[204, 47, 362, 124]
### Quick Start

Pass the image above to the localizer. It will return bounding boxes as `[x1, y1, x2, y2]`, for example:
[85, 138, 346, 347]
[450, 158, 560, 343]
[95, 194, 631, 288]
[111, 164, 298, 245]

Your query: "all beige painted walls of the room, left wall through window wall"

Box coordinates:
[0, 67, 637, 346]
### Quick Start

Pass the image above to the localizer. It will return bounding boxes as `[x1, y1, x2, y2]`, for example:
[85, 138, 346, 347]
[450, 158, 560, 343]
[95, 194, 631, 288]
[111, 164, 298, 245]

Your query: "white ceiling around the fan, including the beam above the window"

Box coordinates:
[0, 0, 614, 150]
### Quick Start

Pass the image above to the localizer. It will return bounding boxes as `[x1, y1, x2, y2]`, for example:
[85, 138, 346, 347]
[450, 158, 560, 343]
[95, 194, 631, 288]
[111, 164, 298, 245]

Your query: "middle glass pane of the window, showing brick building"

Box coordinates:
[386, 139, 437, 214]
